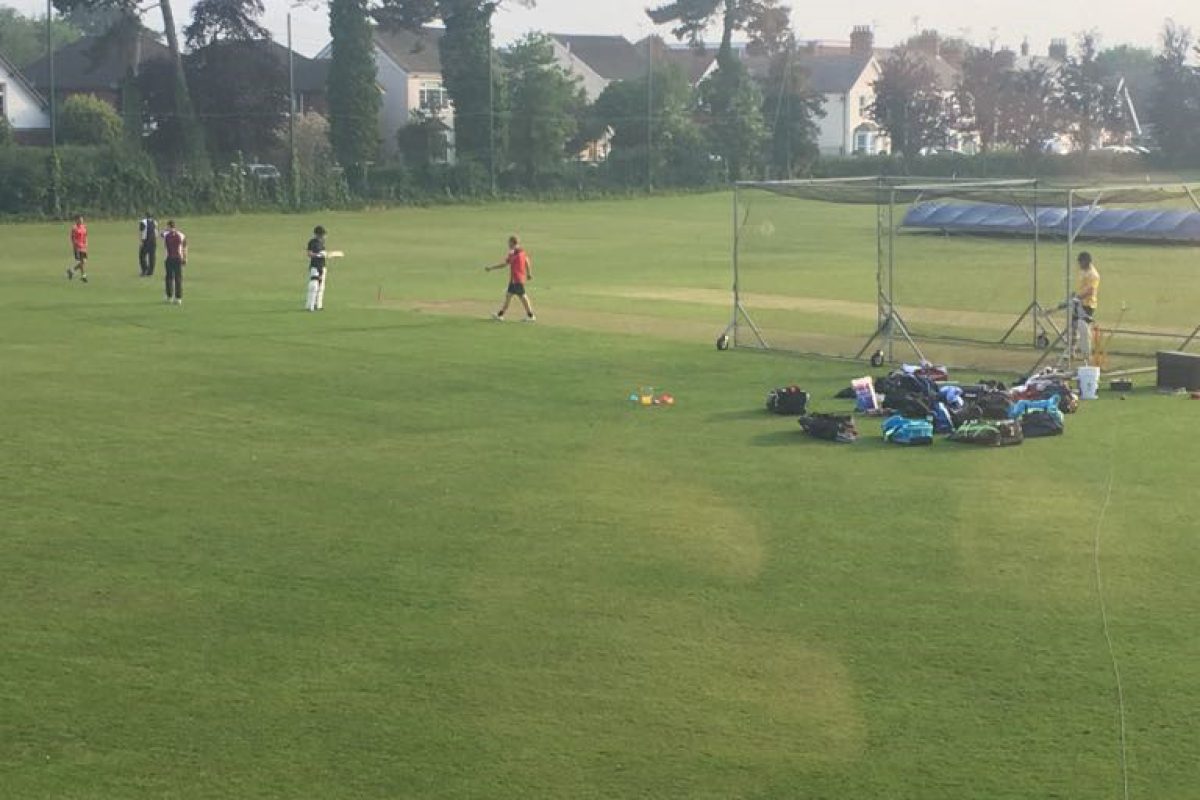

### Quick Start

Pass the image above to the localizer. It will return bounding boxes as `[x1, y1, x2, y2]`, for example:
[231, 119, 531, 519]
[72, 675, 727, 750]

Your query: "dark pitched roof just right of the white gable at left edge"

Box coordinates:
[25, 32, 170, 92]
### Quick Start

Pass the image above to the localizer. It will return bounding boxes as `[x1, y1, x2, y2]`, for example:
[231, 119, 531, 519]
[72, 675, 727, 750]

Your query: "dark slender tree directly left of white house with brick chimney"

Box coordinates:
[762, 38, 824, 180]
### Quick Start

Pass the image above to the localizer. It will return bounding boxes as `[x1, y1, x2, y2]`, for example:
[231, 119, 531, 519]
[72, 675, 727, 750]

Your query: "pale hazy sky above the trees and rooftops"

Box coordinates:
[0, 0, 1200, 55]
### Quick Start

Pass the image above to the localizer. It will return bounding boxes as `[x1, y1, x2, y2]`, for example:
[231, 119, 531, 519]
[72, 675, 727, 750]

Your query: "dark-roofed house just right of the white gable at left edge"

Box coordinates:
[25, 31, 170, 112]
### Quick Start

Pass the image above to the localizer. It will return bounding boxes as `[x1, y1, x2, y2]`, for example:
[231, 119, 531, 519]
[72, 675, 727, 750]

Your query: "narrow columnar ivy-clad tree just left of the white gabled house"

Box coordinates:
[329, 0, 380, 185]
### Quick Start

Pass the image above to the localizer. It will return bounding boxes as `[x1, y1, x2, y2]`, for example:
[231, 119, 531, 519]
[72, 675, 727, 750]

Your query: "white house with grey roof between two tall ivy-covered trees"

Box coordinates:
[317, 28, 454, 161]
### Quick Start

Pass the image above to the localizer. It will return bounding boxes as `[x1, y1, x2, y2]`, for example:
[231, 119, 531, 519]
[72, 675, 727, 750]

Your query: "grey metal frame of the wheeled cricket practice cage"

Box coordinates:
[721, 175, 1200, 372]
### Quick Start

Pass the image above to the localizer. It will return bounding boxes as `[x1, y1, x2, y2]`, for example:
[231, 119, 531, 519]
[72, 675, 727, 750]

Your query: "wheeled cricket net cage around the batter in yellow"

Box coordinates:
[722, 178, 1200, 373]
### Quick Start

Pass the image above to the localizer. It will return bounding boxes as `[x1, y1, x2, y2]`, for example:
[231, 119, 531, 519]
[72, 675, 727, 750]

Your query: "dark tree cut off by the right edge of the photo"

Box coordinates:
[1152, 19, 1200, 163]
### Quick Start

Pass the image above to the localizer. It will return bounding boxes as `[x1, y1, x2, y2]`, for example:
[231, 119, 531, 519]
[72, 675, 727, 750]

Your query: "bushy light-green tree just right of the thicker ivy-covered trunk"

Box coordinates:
[502, 34, 587, 185]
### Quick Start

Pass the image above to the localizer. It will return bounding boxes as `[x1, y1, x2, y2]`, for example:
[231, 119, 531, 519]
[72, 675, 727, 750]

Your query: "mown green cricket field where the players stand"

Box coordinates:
[0, 196, 1200, 800]
